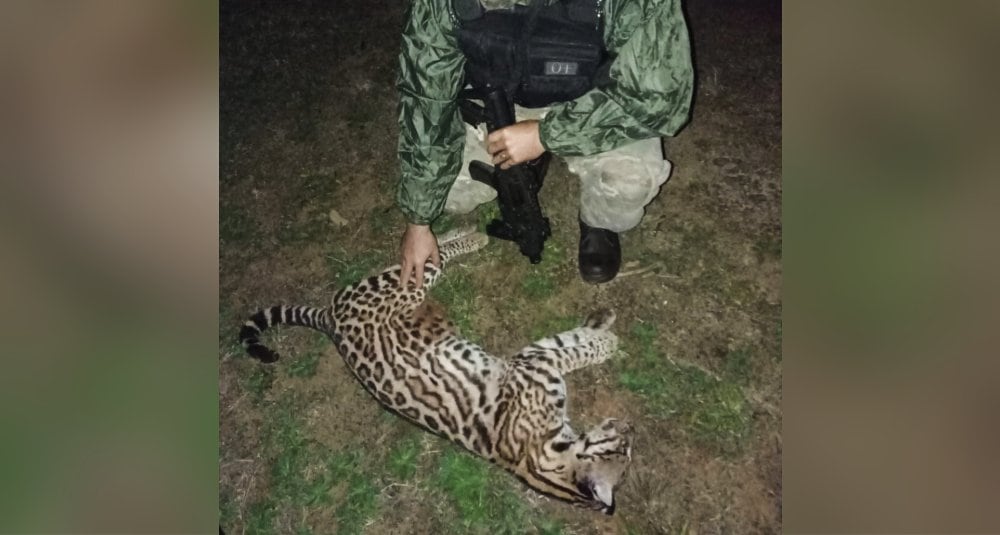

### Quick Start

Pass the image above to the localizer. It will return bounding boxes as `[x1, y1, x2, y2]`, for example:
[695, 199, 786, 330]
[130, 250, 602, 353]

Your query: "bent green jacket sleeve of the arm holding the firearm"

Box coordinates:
[540, 0, 694, 156]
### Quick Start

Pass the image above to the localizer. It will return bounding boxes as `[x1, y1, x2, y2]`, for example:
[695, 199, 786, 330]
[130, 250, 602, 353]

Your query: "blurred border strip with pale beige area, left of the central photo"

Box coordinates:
[0, 0, 218, 533]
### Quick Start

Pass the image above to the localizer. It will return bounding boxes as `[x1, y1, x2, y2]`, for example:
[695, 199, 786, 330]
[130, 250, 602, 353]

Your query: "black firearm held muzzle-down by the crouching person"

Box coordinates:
[461, 87, 552, 264]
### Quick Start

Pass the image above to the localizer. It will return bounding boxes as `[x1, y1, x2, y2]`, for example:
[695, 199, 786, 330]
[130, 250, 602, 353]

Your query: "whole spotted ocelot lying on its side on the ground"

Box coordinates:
[240, 227, 632, 515]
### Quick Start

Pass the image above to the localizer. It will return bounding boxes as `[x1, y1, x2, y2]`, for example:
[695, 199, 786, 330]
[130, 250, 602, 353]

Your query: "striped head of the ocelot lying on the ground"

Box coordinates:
[552, 418, 632, 515]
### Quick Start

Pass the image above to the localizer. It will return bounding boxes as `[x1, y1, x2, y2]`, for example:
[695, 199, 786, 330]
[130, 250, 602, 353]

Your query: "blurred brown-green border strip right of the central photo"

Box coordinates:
[782, 1, 1000, 533]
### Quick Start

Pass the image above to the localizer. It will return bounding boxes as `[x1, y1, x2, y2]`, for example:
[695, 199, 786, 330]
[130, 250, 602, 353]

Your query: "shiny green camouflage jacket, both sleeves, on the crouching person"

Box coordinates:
[396, 0, 694, 224]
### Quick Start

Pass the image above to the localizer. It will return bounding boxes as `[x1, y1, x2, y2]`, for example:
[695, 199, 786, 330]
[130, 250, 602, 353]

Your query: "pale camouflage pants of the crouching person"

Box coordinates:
[445, 108, 671, 232]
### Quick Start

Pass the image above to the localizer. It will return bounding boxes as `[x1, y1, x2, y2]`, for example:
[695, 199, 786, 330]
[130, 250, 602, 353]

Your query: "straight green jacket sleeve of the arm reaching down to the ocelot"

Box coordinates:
[396, 0, 465, 224]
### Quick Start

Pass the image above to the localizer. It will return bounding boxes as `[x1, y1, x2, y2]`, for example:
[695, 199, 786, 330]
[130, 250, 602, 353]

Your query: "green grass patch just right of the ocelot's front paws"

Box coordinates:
[618, 323, 751, 454]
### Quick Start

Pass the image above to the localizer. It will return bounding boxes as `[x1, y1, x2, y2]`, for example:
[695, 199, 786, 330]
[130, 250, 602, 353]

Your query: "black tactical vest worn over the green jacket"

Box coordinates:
[452, 0, 611, 108]
